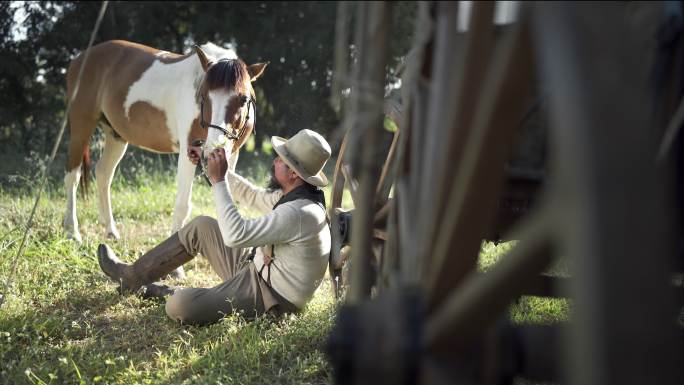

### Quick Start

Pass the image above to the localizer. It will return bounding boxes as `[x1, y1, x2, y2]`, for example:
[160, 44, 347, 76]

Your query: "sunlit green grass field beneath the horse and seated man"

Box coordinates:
[0, 158, 568, 384]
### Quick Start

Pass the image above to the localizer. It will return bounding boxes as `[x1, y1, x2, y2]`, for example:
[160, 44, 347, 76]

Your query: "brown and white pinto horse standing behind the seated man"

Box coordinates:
[64, 40, 266, 242]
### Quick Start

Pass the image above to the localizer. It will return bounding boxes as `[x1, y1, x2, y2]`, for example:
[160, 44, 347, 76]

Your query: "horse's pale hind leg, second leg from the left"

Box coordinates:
[95, 128, 128, 239]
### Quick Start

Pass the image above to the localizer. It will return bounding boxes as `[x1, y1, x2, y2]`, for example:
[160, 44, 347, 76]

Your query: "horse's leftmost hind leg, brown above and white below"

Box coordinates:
[62, 111, 97, 243]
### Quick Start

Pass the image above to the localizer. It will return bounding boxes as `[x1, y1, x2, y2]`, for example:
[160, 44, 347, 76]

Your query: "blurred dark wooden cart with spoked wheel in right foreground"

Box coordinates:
[328, 2, 684, 384]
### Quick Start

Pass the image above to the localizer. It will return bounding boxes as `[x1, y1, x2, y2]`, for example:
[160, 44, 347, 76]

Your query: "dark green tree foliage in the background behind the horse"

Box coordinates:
[0, 1, 416, 183]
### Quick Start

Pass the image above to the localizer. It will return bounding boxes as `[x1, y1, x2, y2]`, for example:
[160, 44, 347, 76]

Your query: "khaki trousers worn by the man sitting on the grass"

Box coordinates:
[166, 216, 298, 324]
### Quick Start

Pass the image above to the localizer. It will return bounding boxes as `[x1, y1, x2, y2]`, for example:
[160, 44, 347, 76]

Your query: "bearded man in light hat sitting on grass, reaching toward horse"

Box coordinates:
[97, 130, 330, 324]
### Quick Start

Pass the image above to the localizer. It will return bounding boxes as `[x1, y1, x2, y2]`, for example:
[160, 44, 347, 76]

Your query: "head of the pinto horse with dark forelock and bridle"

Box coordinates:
[195, 45, 268, 156]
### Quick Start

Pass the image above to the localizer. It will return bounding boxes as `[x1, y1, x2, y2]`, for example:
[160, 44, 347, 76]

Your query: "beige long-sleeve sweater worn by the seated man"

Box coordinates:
[212, 171, 330, 308]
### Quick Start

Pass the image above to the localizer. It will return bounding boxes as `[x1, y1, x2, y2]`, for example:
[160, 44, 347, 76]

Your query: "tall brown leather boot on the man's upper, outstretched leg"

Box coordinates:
[97, 233, 193, 291]
